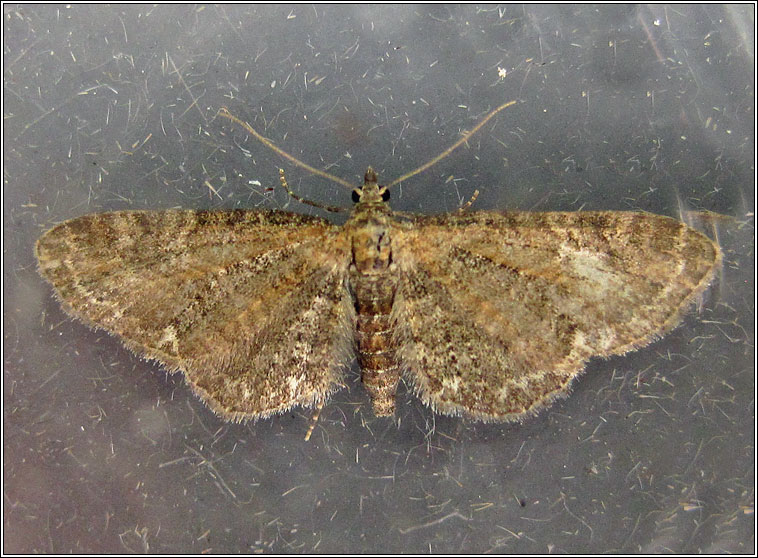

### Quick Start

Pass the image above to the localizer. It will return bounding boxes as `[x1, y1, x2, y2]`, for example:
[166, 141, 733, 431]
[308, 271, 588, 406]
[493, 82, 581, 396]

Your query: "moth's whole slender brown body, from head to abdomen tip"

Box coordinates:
[345, 167, 400, 416]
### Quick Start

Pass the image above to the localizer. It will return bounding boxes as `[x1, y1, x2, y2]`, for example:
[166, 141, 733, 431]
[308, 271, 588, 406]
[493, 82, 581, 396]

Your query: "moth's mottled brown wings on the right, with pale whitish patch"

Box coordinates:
[393, 212, 721, 420]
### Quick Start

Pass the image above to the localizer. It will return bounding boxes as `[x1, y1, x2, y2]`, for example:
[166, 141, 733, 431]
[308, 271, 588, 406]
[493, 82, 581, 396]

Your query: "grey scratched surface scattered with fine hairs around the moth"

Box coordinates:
[3, 4, 755, 553]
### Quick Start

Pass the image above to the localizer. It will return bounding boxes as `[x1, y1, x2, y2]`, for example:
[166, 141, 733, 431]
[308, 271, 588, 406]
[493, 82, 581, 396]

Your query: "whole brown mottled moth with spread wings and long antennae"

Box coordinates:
[36, 103, 721, 428]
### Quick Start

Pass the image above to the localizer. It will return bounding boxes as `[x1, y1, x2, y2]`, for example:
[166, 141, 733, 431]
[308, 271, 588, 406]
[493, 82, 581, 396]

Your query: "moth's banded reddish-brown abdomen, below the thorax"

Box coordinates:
[352, 273, 400, 416]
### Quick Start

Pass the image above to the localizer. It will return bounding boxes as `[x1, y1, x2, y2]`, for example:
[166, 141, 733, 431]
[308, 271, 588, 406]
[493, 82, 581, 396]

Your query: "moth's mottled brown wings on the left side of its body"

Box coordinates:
[37, 210, 355, 420]
